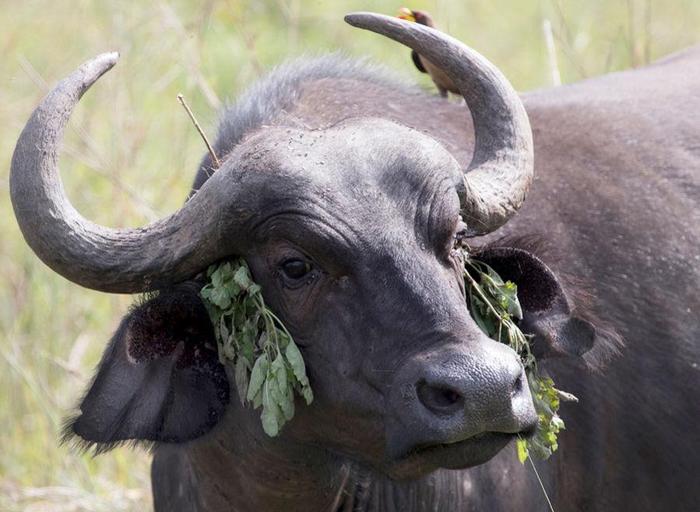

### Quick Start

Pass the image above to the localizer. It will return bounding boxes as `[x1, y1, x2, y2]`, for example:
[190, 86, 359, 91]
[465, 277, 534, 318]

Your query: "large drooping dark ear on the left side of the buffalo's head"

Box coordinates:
[64, 283, 230, 452]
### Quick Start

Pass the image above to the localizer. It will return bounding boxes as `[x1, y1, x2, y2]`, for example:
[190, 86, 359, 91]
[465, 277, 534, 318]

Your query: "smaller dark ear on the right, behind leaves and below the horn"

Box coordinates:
[475, 247, 596, 359]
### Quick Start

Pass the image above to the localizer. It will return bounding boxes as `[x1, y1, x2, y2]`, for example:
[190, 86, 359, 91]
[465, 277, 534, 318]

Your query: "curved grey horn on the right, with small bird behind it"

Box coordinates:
[345, 13, 533, 236]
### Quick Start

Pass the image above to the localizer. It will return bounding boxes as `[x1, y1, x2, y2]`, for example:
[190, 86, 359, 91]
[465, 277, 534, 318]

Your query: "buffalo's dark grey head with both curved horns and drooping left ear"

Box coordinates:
[11, 14, 584, 476]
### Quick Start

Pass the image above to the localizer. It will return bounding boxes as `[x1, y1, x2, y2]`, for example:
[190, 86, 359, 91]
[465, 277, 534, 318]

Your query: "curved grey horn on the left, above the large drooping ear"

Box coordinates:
[10, 53, 242, 293]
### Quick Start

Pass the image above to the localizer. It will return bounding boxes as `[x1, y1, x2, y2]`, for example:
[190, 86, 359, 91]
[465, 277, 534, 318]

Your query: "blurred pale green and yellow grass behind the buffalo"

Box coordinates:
[0, 0, 700, 511]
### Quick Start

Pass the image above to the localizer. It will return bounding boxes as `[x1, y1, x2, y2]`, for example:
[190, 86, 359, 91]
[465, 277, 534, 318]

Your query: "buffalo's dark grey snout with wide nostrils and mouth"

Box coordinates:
[387, 338, 537, 467]
